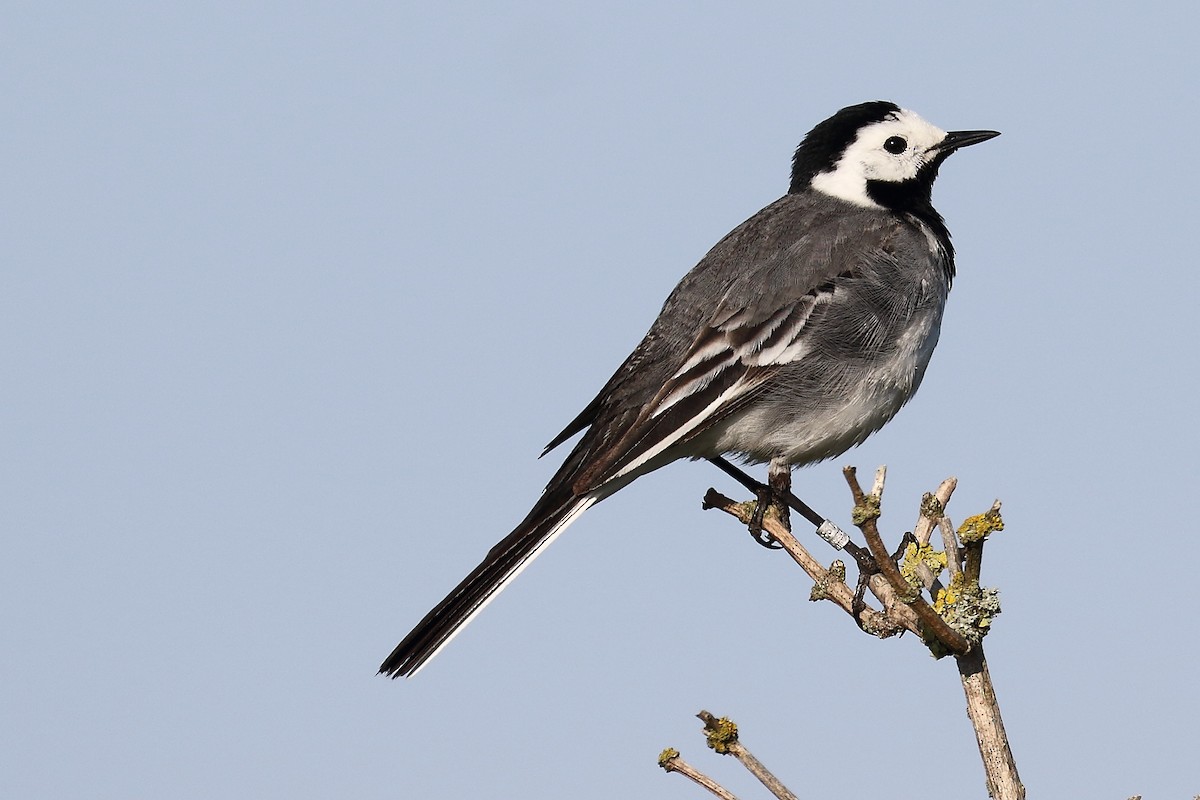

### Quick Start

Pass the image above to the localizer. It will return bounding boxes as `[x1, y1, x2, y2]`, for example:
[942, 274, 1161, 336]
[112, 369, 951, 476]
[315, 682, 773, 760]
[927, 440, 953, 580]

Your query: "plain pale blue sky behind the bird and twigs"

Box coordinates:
[0, 2, 1200, 800]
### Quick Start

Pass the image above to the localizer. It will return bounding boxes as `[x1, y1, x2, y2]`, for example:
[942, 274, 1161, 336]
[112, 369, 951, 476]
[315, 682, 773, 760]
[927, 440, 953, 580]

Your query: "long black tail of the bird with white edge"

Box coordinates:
[379, 492, 599, 678]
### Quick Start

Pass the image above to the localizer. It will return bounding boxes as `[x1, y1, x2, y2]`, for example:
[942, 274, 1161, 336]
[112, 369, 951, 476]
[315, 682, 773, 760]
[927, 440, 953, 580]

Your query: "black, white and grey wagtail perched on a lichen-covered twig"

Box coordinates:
[379, 101, 1000, 678]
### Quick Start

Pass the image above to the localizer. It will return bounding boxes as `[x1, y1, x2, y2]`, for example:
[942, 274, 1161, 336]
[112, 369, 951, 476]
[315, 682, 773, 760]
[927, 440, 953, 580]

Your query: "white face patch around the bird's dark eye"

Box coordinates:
[812, 109, 946, 207]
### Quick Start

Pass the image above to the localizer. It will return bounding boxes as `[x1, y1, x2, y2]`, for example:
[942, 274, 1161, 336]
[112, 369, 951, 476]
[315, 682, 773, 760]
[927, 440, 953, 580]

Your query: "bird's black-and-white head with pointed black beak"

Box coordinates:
[788, 101, 1000, 211]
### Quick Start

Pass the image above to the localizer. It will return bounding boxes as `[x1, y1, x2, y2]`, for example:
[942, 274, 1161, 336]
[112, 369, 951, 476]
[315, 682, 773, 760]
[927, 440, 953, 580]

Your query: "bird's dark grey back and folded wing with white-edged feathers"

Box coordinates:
[546, 194, 928, 494]
